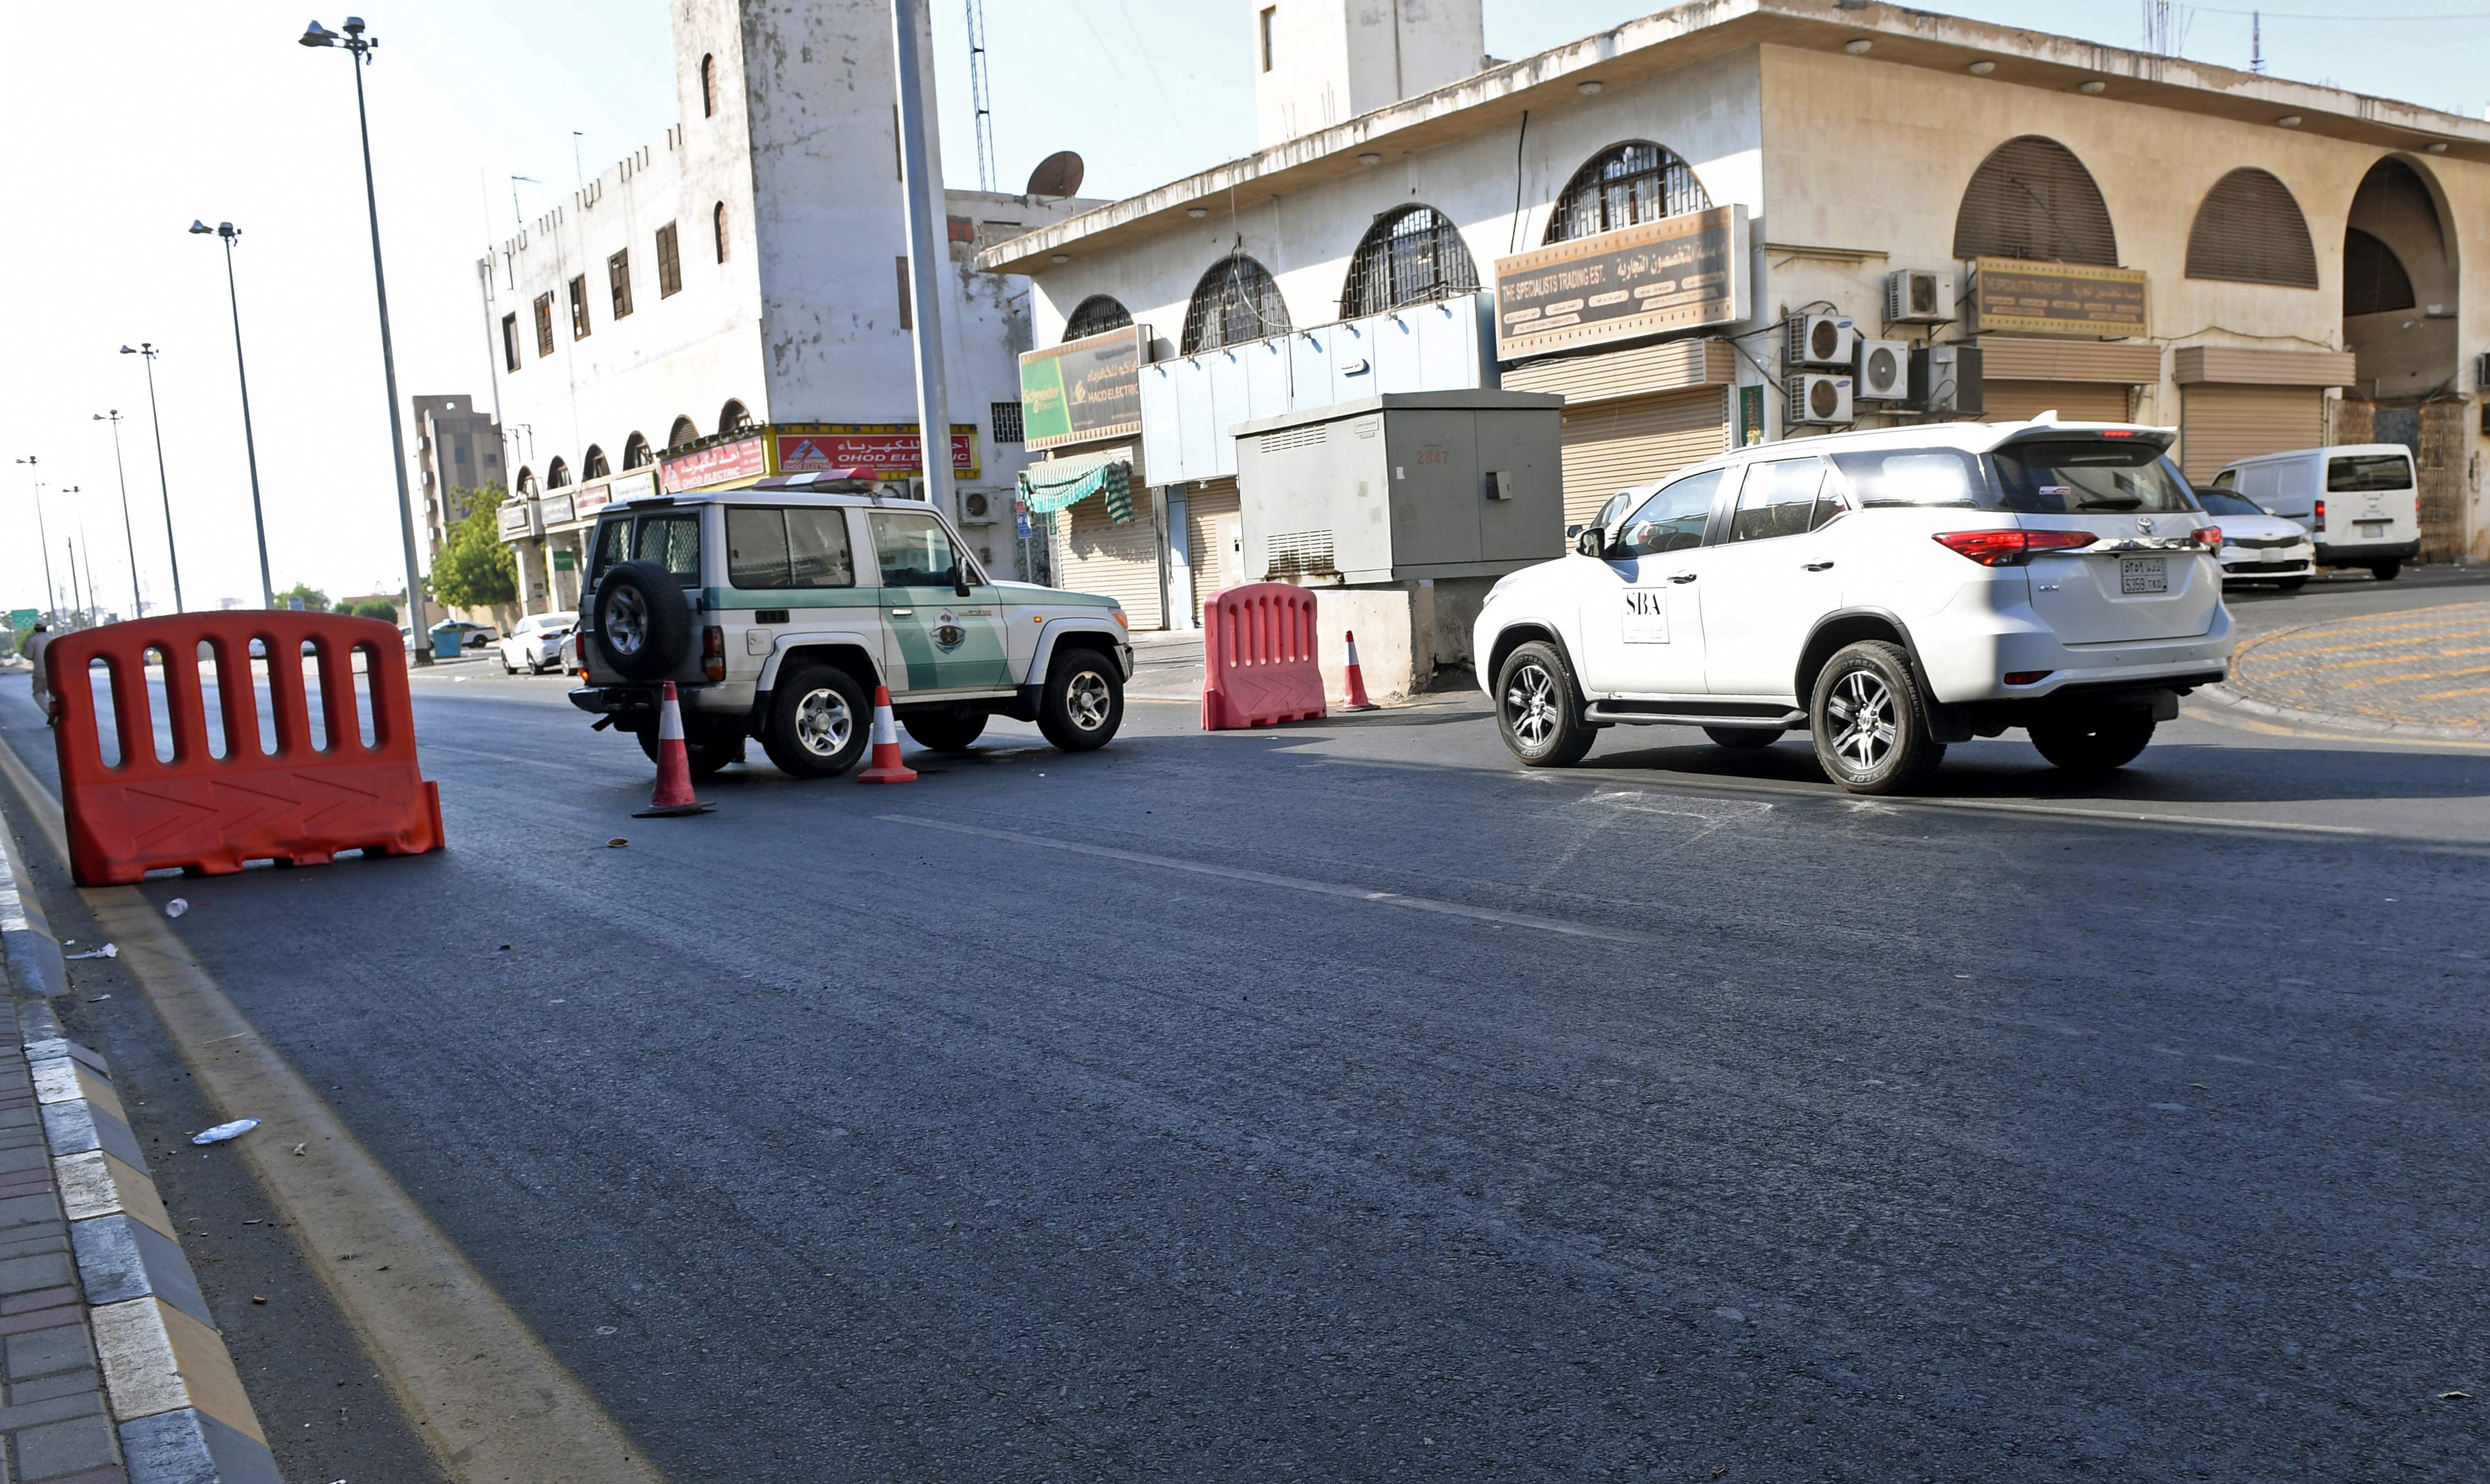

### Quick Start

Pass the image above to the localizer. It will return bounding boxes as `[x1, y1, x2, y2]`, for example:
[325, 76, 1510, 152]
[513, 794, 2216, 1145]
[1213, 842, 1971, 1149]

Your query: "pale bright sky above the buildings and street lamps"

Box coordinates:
[0, 0, 2490, 612]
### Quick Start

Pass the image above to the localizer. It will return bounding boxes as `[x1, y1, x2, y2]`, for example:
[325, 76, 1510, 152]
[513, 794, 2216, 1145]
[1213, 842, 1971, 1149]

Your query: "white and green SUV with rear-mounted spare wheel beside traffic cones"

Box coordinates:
[570, 473, 1133, 777]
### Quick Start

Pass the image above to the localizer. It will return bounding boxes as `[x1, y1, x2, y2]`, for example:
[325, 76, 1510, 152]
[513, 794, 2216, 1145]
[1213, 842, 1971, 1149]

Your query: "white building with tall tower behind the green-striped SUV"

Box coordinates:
[486, 0, 1093, 612]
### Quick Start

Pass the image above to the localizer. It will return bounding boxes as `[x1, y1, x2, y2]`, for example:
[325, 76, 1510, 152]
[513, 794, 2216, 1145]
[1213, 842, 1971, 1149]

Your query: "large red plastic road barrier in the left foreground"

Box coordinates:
[42, 612, 441, 886]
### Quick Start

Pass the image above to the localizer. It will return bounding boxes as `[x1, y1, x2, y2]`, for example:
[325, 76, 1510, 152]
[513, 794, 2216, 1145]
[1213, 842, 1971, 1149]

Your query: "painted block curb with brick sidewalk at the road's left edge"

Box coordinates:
[0, 822, 279, 1484]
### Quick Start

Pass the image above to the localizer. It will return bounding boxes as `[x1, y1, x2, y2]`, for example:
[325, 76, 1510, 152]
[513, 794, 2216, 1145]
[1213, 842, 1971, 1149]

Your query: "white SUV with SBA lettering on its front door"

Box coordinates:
[1472, 413, 2231, 794]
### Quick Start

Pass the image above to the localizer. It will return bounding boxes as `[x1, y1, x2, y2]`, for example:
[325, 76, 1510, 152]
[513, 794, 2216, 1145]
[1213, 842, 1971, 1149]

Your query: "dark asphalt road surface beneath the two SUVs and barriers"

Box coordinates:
[0, 570, 2490, 1484]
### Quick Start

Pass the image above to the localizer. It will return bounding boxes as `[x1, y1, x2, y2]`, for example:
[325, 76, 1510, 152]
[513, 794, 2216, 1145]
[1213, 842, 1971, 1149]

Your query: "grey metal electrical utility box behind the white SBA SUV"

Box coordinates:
[1230, 391, 1564, 585]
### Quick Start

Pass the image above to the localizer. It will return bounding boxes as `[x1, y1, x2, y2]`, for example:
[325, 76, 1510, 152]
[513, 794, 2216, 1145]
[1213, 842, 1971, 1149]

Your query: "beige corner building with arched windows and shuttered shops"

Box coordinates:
[979, 0, 2490, 627]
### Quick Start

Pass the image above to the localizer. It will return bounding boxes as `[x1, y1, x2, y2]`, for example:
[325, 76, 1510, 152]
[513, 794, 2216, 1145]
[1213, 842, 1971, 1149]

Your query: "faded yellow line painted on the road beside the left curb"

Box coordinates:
[0, 742, 665, 1484]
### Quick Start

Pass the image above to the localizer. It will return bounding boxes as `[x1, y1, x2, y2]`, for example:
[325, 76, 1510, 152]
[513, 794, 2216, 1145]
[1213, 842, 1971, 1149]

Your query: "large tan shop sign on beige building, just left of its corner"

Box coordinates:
[1496, 207, 1751, 361]
